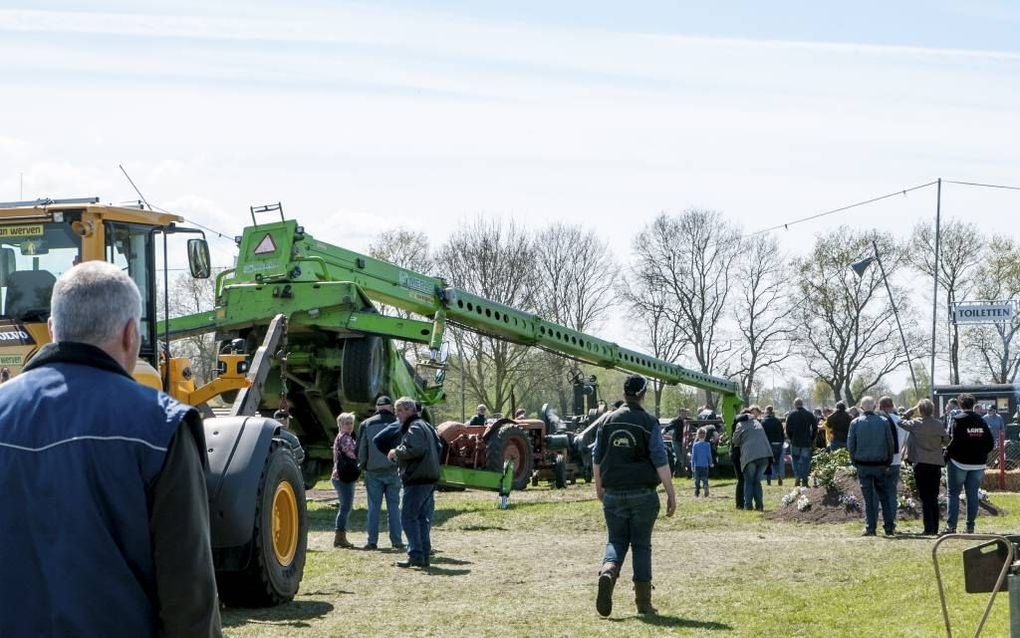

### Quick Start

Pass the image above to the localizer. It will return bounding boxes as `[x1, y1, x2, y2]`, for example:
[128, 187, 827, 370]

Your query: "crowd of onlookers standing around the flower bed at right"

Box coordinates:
[665, 394, 1005, 536]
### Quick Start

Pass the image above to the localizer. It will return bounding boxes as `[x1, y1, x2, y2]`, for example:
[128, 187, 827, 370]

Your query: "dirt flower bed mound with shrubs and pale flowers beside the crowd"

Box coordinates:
[765, 470, 1006, 523]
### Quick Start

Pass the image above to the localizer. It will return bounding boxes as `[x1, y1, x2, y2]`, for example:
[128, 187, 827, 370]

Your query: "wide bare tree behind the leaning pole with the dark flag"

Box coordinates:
[793, 226, 916, 404]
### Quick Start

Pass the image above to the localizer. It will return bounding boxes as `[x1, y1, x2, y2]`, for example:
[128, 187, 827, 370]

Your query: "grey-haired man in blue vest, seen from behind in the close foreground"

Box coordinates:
[0, 261, 220, 636]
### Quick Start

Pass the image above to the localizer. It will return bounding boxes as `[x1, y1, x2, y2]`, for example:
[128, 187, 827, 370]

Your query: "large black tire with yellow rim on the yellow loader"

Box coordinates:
[216, 439, 308, 607]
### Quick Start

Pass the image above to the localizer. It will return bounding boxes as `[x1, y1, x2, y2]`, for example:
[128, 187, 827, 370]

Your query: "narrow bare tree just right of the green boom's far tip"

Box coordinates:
[734, 237, 796, 403]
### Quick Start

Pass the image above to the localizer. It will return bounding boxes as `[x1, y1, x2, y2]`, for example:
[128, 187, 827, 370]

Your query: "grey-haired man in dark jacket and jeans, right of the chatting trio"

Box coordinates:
[387, 396, 441, 569]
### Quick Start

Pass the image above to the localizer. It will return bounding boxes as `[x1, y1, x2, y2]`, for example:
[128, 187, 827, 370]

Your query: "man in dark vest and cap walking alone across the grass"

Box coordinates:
[592, 375, 676, 616]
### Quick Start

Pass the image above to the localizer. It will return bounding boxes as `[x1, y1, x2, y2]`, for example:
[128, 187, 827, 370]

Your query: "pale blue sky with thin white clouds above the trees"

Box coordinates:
[0, 0, 1020, 383]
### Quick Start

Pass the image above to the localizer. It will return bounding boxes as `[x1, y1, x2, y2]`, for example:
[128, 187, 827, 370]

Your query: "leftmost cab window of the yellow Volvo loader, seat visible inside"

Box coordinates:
[0, 222, 82, 322]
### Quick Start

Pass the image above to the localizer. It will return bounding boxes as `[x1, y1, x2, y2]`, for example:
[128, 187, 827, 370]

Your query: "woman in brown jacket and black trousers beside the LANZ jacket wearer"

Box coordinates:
[900, 399, 950, 536]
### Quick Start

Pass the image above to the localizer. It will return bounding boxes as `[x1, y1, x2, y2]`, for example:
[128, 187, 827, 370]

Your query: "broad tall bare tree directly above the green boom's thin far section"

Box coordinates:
[633, 209, 741, 403]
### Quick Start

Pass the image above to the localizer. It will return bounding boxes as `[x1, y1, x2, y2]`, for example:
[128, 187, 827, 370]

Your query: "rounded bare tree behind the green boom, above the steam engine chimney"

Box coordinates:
[533, 224, 617, 413]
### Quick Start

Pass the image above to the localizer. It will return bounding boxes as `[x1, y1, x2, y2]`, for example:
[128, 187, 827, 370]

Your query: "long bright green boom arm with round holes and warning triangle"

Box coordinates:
[159, 220, 740, 421]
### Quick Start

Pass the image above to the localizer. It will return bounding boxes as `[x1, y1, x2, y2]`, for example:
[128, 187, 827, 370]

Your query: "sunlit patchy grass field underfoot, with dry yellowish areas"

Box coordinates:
[223, 481, 1020, 638]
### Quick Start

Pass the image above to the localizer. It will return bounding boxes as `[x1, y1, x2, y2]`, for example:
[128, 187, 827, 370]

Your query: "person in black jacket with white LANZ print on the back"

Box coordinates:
[944, 394, 996, 534]
